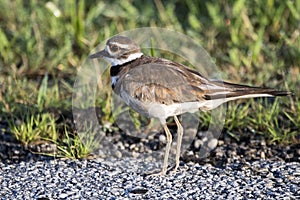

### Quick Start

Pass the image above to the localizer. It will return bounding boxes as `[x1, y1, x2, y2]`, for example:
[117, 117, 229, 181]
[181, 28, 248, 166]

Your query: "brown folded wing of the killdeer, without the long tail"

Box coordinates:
[119, 60, 209, 105]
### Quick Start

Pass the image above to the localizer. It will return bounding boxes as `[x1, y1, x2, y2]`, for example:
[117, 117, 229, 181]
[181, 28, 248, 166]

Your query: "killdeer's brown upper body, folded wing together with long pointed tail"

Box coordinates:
[116, 56, 290, 105]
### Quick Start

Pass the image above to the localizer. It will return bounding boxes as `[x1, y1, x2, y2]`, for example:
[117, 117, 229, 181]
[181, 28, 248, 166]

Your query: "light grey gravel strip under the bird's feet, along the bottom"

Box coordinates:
[0, 159, 300, 199]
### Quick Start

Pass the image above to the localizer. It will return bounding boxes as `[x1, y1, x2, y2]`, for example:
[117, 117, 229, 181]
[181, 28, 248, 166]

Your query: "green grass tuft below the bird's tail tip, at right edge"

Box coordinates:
[225, 98, 299, 144]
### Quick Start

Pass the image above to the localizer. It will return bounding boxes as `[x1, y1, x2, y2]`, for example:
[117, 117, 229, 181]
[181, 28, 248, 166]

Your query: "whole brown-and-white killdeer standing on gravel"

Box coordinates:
[90, 36, 290, 175]
